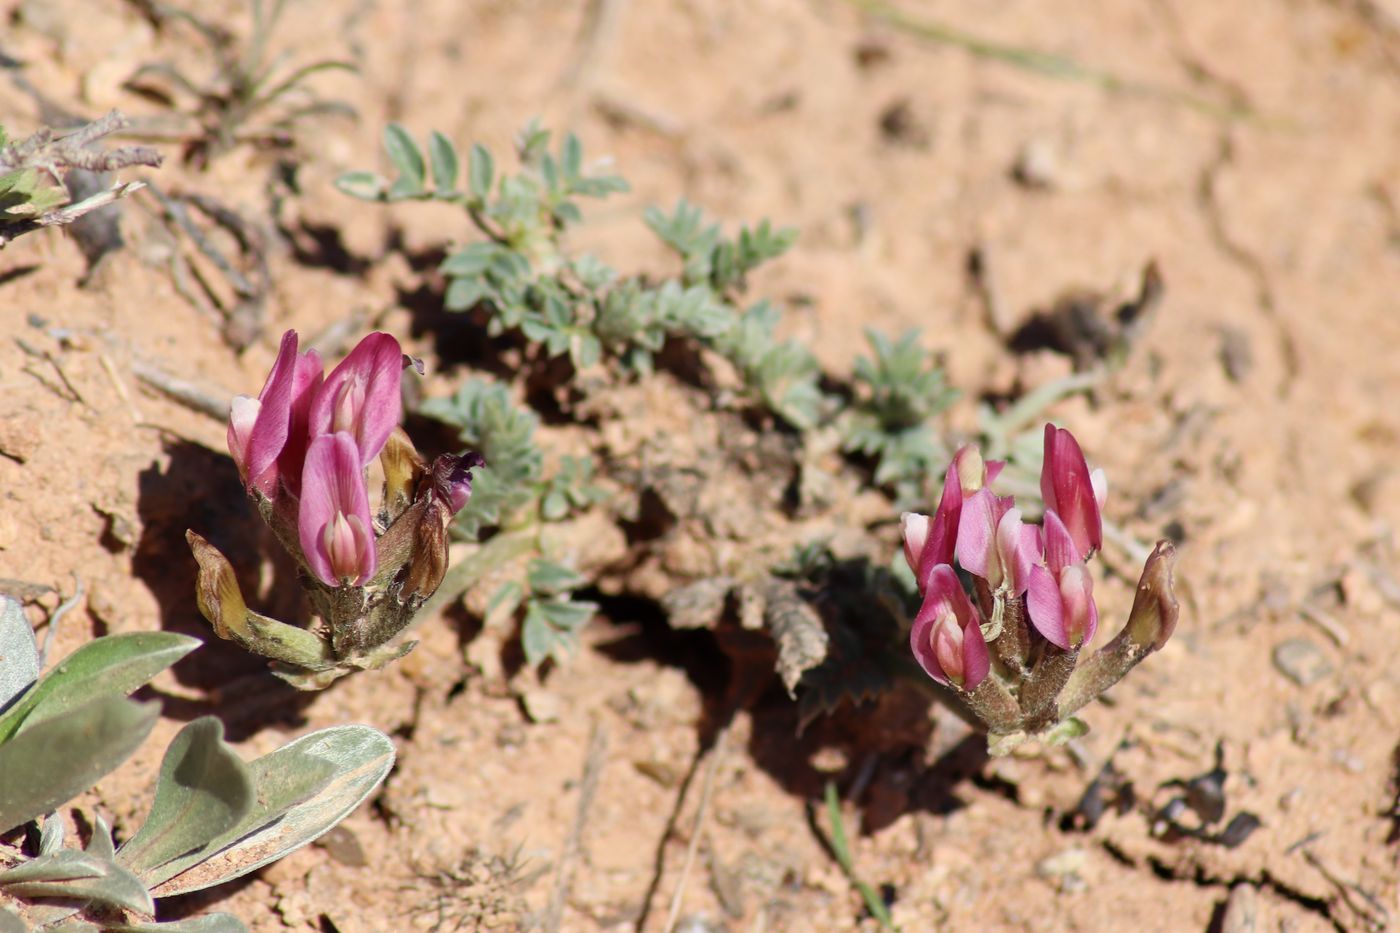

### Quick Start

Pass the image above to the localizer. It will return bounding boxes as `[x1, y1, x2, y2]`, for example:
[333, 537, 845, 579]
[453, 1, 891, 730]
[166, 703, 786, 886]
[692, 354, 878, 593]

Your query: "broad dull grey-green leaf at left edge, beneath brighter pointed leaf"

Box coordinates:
[0, 696, 160, 832]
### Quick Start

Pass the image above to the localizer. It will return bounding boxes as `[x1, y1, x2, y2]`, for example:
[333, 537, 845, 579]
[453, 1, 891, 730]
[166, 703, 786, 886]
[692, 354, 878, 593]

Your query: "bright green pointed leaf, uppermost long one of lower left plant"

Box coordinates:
[0, 632, 202, 741]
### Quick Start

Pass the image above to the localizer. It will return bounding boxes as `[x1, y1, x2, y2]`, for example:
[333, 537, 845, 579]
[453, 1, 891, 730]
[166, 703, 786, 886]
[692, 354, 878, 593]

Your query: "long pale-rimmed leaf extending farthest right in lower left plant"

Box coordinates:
[154, 726, 393, 897]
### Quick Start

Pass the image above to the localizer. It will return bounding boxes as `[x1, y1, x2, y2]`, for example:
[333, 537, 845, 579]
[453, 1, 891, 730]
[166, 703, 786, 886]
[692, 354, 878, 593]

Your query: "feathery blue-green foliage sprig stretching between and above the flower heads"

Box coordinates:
[337, 123, 823, 406]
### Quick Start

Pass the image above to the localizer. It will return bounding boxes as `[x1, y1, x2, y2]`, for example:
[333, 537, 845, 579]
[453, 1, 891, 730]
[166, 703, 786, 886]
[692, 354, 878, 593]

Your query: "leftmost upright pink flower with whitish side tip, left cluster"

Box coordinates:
[228, 331, 321, 497]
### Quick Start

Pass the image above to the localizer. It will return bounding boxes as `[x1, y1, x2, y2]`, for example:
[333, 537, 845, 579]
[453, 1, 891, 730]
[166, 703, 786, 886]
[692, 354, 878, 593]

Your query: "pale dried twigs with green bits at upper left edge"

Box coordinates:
[0, 111, 161, 248]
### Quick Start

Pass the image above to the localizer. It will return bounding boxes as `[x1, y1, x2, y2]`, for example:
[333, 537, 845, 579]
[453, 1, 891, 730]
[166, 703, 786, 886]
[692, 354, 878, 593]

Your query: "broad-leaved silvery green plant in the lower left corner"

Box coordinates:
[0, 597, 393, 933]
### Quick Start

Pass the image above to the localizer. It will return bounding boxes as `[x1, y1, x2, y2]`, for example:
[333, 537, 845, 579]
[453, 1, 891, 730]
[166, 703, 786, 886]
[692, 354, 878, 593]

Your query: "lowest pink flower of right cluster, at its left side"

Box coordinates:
[909, 565, 990, 692]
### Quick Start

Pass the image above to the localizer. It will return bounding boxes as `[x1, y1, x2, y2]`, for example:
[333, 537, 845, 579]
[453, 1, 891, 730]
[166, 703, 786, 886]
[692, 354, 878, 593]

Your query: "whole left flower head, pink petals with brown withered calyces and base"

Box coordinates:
[186, 331, 482, 689]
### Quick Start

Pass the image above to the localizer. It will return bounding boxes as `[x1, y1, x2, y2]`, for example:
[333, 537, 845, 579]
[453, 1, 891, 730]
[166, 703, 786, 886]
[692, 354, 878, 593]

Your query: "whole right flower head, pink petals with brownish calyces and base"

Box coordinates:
[902, 424, 1177, 752]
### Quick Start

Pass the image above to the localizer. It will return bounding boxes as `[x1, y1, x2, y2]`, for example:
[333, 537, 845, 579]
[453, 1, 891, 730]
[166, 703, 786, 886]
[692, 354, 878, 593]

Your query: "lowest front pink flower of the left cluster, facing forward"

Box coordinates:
[297, 431, 378, 587]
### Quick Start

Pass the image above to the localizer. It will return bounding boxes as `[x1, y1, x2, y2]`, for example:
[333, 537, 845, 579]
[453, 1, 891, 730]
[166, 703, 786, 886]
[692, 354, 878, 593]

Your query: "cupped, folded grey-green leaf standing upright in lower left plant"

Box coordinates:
[118, 716, 256, 877]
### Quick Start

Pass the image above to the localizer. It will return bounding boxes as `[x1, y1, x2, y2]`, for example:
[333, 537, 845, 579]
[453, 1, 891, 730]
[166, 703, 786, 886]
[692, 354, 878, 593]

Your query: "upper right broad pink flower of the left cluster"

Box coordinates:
[309, 333, 403, 467]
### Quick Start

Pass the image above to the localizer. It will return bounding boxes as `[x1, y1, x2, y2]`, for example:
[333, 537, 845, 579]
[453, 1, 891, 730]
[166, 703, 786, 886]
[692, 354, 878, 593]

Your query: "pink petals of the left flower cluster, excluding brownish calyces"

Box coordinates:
[228, 331, 459, 587]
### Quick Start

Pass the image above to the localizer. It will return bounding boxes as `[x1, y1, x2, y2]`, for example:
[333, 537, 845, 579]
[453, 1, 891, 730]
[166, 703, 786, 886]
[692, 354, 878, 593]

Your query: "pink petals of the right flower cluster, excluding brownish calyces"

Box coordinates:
[902, 424, 1107, 692]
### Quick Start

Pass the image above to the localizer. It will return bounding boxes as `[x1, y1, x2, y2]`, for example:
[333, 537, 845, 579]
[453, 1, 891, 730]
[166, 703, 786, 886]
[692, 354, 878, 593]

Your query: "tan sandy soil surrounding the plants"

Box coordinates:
[0, 0, 1400, 933]
